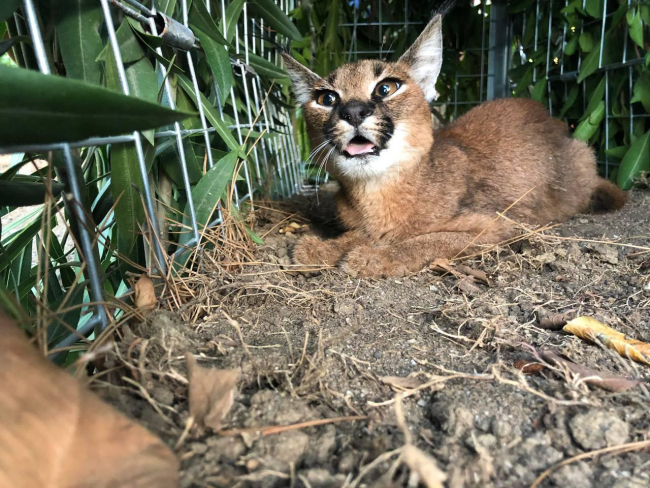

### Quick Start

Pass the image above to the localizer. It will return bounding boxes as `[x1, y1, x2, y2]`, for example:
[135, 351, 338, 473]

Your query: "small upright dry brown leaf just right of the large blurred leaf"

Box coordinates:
[185, 352, 239, 430]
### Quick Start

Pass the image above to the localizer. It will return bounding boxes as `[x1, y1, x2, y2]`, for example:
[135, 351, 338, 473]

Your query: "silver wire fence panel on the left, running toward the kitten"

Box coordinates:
[0, 0, 304, 358]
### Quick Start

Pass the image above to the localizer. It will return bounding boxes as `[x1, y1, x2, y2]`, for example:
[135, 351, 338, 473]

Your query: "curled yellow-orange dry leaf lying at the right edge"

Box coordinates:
[562, 317, 650, 365]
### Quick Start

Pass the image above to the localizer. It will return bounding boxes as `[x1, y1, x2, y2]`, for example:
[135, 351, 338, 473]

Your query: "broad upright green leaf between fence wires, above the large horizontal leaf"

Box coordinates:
[56, 0, 104, 84]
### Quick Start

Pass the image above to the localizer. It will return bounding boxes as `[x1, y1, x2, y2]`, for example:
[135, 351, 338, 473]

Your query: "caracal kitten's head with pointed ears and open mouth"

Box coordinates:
[284, 15, 442, 180]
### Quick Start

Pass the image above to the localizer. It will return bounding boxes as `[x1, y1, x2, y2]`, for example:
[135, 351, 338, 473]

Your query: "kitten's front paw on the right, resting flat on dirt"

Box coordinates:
[341, 246, 409, 278]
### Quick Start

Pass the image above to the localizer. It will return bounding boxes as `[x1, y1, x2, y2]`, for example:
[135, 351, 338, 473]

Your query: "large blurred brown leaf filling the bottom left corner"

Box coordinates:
[0, 316, 178, 488]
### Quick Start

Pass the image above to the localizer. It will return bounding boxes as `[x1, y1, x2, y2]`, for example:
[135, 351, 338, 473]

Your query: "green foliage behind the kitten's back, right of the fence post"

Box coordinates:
[510, 0, 650, 188]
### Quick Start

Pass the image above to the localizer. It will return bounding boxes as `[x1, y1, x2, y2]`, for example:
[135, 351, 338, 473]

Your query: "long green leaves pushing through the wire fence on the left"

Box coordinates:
[0, 0, 298, 356]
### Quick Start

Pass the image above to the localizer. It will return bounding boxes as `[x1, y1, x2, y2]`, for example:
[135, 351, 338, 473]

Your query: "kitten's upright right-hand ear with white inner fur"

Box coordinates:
[399, 14, 442, 102]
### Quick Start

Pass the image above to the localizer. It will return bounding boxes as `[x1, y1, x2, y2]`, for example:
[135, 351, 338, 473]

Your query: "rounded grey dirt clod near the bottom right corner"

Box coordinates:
[569, 410, 630, 450]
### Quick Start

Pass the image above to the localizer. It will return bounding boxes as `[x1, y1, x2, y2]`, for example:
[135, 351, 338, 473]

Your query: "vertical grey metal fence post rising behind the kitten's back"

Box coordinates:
[487, 0, 510, 100]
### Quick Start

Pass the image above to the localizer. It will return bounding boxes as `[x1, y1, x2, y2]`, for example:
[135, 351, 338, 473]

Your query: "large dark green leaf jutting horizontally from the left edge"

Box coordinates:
[0, 66, 191, 146]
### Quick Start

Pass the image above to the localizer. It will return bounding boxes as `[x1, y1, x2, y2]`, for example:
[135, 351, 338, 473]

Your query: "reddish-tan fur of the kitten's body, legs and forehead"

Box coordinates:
[282, 20, 625, 276]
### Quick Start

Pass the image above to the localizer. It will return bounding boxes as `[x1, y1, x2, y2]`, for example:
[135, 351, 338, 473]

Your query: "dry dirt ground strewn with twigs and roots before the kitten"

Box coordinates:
[95, 191, 650, 488]
